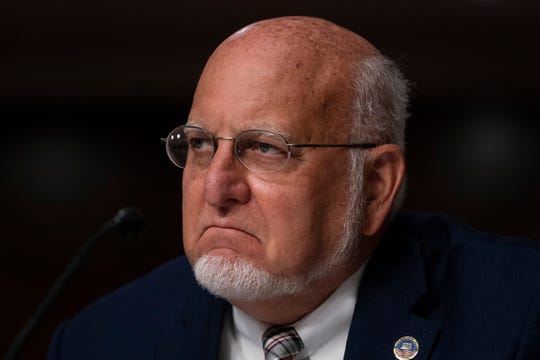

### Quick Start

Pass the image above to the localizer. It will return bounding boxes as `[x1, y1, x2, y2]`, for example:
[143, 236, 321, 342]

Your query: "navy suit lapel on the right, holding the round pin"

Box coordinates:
[345, 217, 438, 360]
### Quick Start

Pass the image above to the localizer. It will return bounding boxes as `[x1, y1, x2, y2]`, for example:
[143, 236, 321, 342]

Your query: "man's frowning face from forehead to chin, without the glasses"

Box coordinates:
[182, 43, 358, 296]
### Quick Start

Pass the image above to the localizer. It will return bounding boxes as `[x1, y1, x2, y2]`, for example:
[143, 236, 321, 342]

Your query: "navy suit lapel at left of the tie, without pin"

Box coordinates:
[155, 290, 230, 360]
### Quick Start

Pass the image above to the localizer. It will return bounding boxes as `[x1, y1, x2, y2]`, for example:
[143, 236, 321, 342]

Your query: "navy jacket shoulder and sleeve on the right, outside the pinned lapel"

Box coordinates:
[377, 213, 540, 359]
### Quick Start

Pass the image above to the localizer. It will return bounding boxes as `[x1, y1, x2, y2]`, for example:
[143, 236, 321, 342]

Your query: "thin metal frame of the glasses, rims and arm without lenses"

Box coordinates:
[161, 125, 379, 174]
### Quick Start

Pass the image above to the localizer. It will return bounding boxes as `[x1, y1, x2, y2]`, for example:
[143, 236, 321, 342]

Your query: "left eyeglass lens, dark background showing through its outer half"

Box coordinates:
[167, 126, 214, 169]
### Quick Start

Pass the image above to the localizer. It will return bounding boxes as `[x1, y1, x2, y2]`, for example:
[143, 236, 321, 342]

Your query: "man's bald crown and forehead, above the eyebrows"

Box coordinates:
[190, 17, 388, 141]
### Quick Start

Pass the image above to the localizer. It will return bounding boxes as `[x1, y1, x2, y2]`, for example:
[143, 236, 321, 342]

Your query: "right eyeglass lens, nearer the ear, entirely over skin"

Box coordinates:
[235, 130, 290, 173]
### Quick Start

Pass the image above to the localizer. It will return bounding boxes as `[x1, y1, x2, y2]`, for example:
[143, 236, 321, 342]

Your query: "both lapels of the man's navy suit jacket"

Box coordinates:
[155, 217, 439, 360]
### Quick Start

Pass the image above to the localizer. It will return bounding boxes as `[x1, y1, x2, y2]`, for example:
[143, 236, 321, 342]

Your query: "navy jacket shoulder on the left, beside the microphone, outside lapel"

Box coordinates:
[49, 257, 212, 359]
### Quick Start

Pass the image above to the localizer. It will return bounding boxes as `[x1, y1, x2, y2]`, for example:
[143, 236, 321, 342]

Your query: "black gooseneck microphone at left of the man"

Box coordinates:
[4, 207, 145, 360]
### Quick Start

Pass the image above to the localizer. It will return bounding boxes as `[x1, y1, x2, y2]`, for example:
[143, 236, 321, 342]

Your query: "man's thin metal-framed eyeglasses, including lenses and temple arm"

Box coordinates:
[161, 125, 377, 173]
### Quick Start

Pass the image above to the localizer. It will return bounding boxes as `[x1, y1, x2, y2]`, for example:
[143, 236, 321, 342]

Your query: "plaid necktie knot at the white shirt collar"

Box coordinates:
[262, 326, 304, 360]
